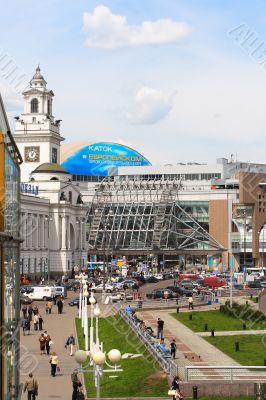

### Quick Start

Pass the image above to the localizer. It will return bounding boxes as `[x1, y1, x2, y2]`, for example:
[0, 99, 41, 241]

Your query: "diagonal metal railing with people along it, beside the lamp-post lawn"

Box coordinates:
[119, 309, 178, 377]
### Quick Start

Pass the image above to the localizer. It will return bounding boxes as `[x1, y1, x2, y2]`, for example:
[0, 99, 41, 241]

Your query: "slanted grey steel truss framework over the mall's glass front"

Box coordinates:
[87, 177, 224, 253]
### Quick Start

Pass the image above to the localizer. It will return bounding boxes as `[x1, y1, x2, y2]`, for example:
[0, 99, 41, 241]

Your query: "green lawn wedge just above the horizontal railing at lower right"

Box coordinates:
[204, 335, 266, 366]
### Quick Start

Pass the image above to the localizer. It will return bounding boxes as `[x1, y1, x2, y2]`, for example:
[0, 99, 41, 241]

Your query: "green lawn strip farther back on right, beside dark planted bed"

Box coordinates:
[171, 310, 265, 332]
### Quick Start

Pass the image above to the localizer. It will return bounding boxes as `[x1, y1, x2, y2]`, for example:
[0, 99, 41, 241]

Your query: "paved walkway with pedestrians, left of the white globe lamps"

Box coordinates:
[21, 292, 77, 400]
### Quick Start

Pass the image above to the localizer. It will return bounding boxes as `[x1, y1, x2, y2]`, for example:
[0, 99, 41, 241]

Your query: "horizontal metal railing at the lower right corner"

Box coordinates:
[185, 365, 266, 382]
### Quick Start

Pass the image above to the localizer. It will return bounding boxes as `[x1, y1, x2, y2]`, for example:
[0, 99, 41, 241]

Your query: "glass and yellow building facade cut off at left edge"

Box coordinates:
[0, 95, 22, 400]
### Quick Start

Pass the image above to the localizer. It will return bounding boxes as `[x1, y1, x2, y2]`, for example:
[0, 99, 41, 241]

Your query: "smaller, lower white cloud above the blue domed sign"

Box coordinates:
[126, 87, 172, 125]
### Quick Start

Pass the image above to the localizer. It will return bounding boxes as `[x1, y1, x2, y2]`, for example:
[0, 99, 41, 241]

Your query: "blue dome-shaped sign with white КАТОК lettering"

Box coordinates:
[62, 142, 151, 176]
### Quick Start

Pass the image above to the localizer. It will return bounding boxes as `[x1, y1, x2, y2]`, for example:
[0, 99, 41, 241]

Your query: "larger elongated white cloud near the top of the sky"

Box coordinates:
[83, 5, 190, 49]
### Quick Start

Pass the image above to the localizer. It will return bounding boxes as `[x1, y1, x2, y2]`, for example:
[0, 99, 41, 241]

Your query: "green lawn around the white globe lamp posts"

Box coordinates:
[76, 316, 169, 398]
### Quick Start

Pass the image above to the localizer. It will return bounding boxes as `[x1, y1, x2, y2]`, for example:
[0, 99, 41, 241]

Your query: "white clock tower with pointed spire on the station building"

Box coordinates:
[14, 66, 64, 182]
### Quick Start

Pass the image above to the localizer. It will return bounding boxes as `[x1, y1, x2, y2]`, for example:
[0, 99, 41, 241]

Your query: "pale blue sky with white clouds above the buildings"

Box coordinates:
[0, 0, 266, 165]
